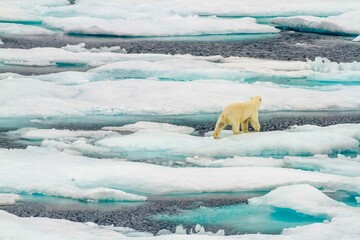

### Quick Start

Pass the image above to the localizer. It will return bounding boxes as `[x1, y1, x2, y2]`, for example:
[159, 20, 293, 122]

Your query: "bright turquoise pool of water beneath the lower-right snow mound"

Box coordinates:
[154, 204, 326, 234]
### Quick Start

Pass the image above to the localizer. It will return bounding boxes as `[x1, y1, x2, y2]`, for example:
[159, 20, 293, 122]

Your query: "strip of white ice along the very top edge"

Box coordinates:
[4, 0, 360, 19]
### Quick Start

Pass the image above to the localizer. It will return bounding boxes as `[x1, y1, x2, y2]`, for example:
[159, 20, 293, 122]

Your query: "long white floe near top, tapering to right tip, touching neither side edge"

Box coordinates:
[44, 16, 279, 37]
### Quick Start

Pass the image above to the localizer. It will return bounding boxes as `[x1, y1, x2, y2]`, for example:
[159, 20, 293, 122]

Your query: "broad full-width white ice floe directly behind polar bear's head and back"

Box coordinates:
[0, 77, 360, 117]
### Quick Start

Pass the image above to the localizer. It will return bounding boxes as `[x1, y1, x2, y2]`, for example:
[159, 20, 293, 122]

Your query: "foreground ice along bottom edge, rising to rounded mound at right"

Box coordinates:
[0, 184, 360, 240]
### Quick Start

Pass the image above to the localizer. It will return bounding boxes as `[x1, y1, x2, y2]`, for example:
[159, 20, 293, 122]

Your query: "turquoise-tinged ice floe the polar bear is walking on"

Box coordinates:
[5, 122, 360, 166]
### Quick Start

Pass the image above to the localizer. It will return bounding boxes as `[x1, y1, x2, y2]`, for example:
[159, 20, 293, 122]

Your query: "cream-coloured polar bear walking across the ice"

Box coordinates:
[213, 96, 261, 139]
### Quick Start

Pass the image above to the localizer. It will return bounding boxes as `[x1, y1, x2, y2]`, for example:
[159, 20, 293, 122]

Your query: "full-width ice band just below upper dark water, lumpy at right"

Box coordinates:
[0, 48, 360, 85]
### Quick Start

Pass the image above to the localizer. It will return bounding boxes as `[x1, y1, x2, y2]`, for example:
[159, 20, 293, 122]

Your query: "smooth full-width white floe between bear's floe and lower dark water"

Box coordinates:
[0, 147, 360, 201]
